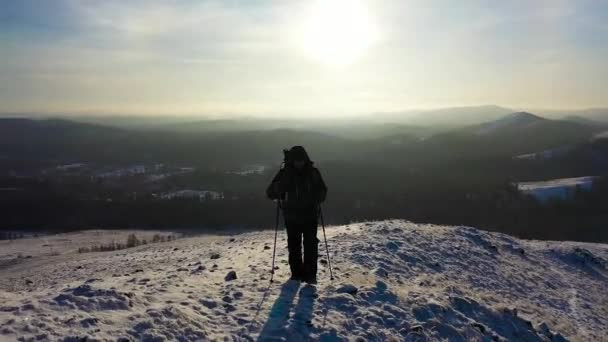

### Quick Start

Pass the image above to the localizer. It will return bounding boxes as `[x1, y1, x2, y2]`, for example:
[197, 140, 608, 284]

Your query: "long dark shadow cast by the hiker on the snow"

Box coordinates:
[258, 281, 316, 341]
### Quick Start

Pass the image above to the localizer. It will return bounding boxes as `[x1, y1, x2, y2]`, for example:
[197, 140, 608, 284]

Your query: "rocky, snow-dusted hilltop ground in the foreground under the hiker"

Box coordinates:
[0, 220, 608, 341]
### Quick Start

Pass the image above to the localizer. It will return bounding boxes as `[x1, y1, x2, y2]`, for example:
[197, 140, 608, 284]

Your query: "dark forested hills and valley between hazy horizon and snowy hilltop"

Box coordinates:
[0, 113, 608, 241]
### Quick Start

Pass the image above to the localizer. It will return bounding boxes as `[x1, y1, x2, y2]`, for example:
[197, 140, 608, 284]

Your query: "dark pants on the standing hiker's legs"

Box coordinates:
[285, 218, 319, 280]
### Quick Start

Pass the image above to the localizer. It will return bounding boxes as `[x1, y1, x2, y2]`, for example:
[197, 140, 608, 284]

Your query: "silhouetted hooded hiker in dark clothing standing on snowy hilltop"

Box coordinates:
[266, 146, 327, 284]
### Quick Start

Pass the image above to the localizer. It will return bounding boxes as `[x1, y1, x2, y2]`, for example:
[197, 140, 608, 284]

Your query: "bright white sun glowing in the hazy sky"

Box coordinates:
[301, 0, 374, 66]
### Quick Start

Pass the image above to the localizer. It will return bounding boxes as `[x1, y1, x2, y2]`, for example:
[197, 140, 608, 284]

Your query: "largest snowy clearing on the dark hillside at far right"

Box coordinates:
[517, 176, 597, 202]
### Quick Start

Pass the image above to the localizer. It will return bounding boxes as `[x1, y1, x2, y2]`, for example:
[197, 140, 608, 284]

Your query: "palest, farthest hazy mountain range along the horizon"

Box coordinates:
[0, 105, 608, 132]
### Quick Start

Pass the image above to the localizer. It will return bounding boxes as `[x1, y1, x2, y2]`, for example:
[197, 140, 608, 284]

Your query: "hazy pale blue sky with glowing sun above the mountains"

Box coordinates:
[0, 0, 608, 115]
